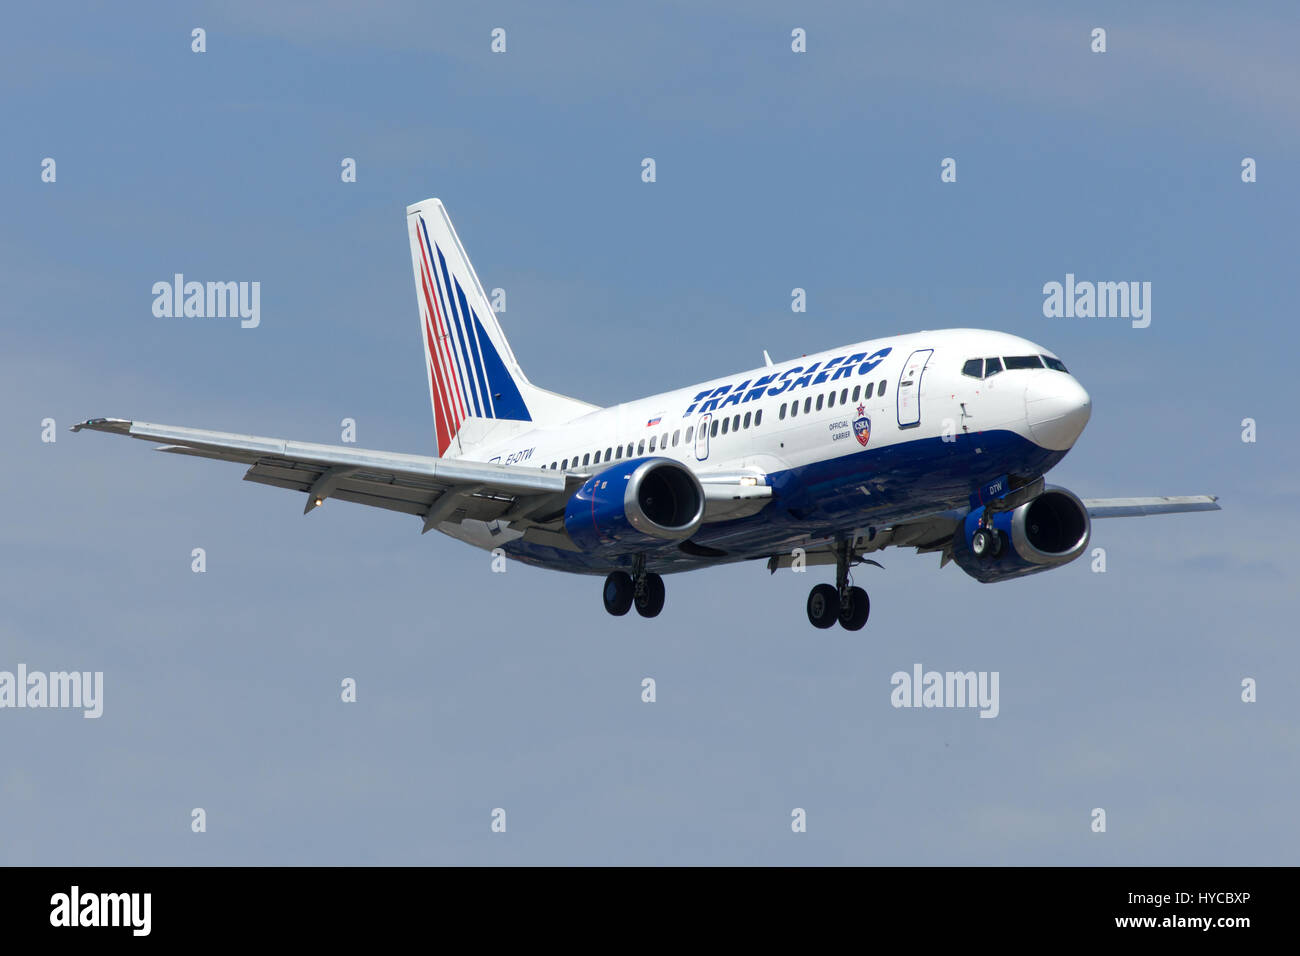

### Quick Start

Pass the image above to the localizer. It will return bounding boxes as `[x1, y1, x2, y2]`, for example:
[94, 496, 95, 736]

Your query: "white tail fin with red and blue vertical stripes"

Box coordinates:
[407, 199, 594, 455]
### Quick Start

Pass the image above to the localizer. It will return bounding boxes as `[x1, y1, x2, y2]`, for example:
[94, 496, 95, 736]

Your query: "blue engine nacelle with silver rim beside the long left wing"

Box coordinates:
[564, 458, 705, 554]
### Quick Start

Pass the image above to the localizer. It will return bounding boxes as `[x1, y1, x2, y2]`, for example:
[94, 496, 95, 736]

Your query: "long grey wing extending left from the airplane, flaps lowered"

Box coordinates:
[73, 419, 582, 531]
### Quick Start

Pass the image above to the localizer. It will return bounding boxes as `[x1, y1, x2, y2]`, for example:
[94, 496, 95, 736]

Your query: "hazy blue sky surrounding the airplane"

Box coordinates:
[0, 3, 1300, 864]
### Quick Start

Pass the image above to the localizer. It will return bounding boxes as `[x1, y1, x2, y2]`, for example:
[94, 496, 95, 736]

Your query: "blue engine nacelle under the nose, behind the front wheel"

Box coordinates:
[953, 488, 1092, 584]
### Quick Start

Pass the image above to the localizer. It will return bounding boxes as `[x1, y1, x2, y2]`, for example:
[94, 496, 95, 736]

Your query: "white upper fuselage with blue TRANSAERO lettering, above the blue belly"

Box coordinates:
[465, 329, 1091, 486]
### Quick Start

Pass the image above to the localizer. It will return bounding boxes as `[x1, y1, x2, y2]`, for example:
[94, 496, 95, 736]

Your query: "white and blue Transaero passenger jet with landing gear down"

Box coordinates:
[73, 199, 1219, 631]
